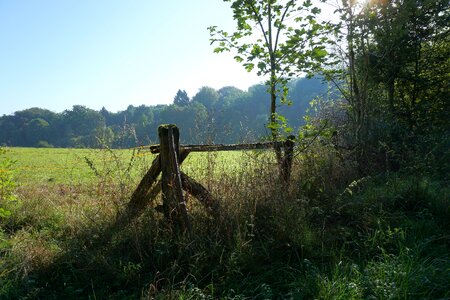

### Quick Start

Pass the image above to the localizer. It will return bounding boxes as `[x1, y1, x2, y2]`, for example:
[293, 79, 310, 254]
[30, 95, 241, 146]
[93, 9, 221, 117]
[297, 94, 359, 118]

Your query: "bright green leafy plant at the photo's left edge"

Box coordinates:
[0, 148, 17, 221]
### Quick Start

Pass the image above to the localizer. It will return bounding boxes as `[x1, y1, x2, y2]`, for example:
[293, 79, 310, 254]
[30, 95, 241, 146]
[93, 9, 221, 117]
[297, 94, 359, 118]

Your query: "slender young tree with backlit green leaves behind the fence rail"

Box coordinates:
[209, 0, 329, 144]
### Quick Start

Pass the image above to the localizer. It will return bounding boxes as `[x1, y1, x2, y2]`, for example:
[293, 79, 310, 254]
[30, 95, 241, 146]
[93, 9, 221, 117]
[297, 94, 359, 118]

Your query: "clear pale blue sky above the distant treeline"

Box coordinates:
[0, 0, 261, 115]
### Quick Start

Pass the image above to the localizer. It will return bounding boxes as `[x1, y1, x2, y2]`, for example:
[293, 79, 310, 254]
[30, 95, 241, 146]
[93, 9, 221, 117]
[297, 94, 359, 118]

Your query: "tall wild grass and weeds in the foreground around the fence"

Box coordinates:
[0, 145, 450, 299]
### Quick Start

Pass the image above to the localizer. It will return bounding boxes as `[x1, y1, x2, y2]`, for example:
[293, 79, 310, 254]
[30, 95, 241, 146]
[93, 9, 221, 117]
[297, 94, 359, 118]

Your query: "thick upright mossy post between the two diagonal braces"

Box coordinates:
[158, 124, 190, 233]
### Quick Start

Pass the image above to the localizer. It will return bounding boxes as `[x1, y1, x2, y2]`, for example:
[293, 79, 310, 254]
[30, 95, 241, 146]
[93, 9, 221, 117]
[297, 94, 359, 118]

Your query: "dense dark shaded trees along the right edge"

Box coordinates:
[328, 0, 450, 173]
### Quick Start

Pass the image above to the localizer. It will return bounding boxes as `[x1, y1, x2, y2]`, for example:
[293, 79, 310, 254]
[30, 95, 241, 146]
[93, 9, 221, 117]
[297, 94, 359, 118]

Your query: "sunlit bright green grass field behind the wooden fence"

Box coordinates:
[0, 147, 254, 184]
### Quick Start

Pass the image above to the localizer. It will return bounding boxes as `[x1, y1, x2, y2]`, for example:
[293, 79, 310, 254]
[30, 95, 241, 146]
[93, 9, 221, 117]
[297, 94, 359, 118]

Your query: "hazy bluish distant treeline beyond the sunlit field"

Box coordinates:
[0, 78, 327, 148]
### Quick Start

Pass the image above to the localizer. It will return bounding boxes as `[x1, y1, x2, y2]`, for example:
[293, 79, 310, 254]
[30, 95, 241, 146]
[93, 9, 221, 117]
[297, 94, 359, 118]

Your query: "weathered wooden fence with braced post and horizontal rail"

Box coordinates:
[118, 124, 294, 233]
